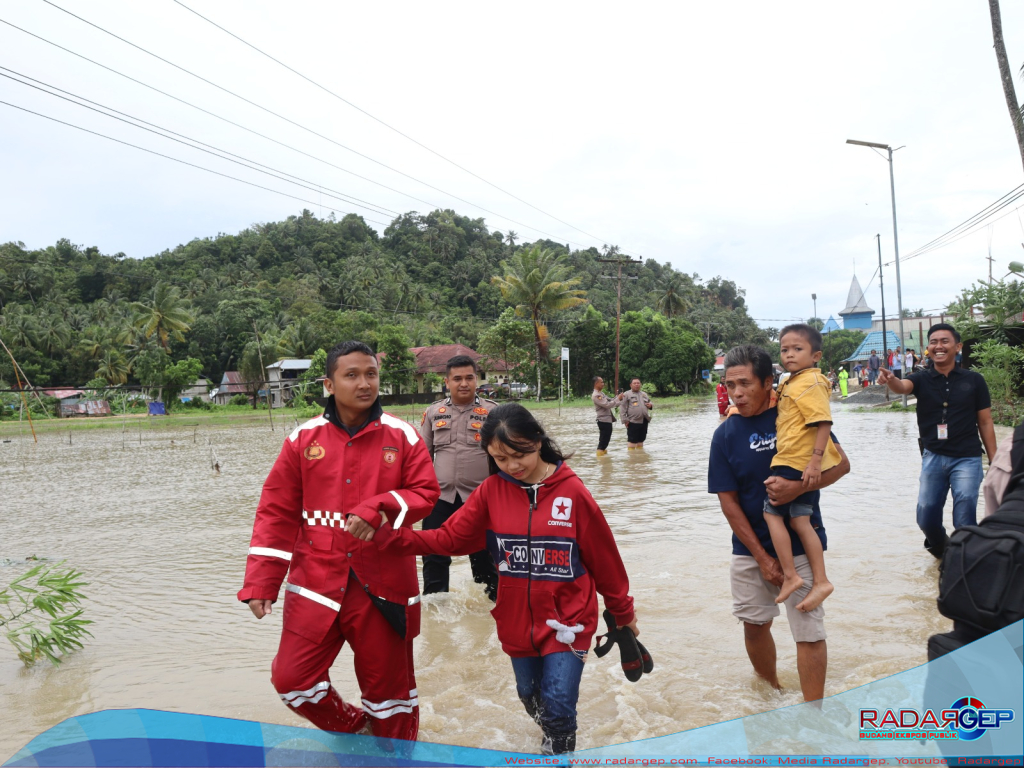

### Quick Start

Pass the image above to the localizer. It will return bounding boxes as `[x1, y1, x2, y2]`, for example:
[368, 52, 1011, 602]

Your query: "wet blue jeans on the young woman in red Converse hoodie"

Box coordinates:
[512, 650, 583, 753]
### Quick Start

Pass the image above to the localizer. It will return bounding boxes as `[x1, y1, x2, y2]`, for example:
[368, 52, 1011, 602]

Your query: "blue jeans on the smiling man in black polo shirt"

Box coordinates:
[918, 451, 983, 545]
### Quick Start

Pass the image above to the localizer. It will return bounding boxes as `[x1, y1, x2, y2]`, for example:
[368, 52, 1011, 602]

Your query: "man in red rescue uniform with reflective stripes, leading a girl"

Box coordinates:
[239, 341, 440, 740]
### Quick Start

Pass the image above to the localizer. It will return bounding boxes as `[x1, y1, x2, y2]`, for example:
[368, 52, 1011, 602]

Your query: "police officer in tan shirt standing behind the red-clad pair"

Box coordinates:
[420, 354, 498, 600]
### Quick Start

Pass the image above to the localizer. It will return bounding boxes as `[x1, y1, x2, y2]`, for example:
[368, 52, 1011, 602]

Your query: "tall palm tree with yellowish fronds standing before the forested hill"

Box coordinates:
[490, 246, 587, 401]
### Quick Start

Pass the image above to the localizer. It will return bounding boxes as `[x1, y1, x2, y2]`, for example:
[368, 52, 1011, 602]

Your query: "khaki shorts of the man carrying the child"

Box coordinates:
[729, 555, 825, 643]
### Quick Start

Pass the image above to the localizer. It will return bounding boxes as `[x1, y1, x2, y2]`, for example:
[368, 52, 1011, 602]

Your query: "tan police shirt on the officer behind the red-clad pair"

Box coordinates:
[420, 397, 498, 503]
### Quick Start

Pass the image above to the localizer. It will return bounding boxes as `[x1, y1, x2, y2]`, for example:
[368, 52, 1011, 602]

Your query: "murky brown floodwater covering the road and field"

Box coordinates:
[0, 400, 950, 761]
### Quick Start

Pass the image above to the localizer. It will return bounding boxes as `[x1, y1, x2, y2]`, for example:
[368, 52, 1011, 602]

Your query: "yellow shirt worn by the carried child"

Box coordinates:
[771, 368, 842, 472]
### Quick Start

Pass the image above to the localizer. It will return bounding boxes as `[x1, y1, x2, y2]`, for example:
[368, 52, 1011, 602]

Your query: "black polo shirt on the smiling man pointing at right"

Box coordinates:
[906, 368, 992, 459]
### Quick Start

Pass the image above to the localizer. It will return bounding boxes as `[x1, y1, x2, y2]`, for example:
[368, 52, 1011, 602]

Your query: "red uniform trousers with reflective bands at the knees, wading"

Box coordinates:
[270, 574, 420, 741]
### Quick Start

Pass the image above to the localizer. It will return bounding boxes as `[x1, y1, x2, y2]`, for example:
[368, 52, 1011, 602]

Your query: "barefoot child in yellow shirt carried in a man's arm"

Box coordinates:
[764, 324, 842, 611]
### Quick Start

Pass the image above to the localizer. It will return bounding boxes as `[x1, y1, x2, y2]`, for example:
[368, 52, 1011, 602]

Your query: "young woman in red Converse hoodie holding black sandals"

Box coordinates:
[387, 403, 639, 754]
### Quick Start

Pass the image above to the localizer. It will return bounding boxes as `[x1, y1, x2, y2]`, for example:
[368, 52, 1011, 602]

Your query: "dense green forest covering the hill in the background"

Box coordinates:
[0, 210, 770, 405]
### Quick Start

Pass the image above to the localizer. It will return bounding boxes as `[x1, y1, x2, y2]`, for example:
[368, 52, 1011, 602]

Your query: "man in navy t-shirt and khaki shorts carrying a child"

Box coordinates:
[708, 346, 850, 701]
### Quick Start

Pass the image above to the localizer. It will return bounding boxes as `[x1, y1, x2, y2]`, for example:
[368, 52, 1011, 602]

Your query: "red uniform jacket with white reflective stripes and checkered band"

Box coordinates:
[239, 399, 440, 642]
